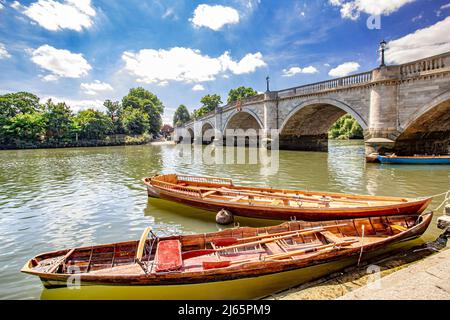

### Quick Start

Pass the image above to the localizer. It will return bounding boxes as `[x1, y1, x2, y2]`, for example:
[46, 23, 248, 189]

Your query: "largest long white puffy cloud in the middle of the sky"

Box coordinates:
[122, 47, 266, 83]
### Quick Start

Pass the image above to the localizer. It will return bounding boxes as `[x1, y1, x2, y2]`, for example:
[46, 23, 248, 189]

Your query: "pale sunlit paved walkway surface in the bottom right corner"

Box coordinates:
[338, 249, 450, 300]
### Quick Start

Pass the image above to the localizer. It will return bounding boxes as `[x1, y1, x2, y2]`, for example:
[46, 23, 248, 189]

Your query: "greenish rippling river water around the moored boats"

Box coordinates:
[0, 141, 450, 299]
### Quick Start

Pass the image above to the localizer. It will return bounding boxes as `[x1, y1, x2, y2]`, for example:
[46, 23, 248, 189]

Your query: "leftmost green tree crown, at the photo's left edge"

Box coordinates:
[0, 92, 41, 118]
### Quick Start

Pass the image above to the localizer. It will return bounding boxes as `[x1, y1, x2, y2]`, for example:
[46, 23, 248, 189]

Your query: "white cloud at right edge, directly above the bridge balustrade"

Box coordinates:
[386, 17, 450, 64]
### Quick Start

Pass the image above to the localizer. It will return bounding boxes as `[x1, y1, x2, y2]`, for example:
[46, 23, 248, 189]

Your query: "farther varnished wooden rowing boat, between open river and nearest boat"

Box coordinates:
[144, 174, 432, 221]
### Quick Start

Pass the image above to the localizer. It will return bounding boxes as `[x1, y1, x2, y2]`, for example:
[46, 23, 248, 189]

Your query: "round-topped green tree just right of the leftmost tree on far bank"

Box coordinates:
[43, 99, 73, 140]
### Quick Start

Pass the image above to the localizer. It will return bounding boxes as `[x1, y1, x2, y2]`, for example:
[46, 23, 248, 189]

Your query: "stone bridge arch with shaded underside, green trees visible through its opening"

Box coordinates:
[279, 98, 368, 151]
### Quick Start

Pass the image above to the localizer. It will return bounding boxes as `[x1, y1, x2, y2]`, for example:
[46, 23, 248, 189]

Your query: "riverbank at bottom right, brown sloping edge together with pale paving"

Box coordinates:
[265, 242, 450, 300]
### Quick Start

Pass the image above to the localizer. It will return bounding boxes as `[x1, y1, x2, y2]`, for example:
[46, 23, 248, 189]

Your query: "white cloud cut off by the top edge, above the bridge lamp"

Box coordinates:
[329, 0, 415, 20]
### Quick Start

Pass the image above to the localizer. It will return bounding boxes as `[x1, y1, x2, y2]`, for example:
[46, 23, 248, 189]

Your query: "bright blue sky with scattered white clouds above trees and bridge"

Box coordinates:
[0, 0, 450, 123]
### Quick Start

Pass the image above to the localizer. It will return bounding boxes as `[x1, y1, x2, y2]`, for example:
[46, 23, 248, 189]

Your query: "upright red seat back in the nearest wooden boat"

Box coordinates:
[155, 240, 183, 272]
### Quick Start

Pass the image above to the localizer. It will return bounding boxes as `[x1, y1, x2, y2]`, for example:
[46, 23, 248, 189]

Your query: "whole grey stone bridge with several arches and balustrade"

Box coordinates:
[175, 52, 450, 159]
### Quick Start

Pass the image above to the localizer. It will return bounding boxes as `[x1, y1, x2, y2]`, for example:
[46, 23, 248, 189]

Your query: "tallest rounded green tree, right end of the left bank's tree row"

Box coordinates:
[122, 87, 164, 133]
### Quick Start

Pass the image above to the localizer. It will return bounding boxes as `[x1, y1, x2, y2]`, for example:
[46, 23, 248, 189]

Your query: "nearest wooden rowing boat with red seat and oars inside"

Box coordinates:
[21, 212, 432, 292]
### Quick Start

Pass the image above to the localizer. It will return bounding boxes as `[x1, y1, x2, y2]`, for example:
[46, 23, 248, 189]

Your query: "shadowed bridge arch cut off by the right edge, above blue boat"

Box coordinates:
[394, 90, 450, 155]
